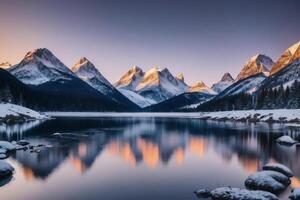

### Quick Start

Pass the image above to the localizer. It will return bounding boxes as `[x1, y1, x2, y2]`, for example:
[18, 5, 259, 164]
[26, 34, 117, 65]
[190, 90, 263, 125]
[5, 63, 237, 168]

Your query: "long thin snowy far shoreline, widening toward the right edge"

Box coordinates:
[46, 109, 300, 124]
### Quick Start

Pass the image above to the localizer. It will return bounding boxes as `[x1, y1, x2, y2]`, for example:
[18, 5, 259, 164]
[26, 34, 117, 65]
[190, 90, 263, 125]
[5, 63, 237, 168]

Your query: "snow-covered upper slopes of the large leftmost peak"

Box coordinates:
[9, 48, 76, 85]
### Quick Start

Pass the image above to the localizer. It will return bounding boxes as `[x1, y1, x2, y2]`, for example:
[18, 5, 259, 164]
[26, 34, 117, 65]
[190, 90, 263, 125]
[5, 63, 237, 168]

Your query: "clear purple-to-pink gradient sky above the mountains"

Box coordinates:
[0, 0, 300, 85]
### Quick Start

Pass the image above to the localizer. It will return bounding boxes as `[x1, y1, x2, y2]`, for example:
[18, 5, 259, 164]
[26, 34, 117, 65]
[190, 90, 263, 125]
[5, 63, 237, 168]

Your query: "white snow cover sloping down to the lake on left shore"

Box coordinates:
[0, 103, 46, 119]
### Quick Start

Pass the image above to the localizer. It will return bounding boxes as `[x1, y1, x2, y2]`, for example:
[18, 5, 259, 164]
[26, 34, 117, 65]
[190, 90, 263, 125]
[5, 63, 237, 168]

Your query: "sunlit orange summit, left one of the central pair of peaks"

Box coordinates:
[115, 66, 144, 91]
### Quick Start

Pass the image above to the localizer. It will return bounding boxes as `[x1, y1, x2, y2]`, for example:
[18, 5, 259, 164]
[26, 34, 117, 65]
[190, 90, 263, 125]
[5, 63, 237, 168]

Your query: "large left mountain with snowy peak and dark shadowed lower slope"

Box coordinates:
[0, 49, 139, 111]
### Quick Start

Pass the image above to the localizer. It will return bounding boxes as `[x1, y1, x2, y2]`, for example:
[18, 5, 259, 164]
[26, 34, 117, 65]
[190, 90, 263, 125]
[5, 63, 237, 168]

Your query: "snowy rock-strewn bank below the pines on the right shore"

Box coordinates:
[200, 109, 300, 123]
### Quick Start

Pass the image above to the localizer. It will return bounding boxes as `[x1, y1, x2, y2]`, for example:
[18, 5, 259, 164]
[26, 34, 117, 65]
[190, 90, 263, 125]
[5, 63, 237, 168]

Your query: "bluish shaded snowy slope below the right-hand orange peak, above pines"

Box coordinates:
[214, 73, 266, 99]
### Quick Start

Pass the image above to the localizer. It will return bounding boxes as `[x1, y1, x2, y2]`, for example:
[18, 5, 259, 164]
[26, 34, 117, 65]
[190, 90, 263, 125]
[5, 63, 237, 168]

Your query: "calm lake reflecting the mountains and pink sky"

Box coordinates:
[0, 117, 300, 200]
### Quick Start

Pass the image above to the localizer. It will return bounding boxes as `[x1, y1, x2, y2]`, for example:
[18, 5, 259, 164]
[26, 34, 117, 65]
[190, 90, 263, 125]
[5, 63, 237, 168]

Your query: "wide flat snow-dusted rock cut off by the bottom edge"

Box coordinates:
[211, 187, 278, 200]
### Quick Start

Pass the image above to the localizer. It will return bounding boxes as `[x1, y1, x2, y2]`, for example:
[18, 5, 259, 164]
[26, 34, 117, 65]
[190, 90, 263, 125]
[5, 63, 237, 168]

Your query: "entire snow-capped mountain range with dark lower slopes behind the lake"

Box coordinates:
[0, 42, 300, 112]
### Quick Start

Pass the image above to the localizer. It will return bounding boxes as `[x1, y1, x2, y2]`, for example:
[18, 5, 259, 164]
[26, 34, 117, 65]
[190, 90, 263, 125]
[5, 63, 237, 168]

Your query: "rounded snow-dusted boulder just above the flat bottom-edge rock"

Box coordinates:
[245, 172, 286, 193]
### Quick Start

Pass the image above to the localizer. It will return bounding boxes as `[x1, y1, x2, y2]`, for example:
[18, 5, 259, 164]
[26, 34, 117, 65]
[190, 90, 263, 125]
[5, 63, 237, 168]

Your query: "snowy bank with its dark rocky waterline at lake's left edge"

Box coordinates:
[0, 103, 47, 123]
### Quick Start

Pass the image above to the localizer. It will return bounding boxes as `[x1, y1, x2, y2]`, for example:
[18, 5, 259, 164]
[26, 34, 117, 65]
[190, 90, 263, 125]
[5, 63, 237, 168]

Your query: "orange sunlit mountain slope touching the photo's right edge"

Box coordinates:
[271, 41, 300, 74]
